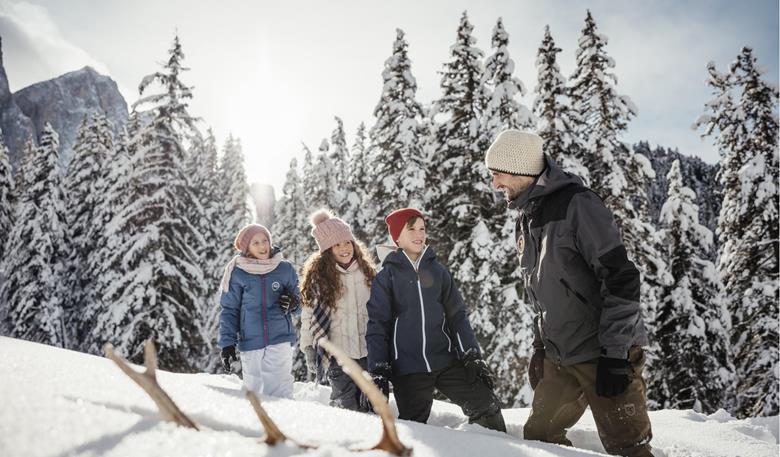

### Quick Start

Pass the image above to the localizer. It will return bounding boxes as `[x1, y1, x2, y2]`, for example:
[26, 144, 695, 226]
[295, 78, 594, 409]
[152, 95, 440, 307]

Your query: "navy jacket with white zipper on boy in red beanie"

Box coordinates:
[366, 247, 479, 375]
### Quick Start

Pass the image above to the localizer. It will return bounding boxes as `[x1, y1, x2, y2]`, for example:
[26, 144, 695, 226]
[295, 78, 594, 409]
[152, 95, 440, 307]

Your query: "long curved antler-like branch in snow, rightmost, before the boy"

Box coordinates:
[318, 338, 412, 455]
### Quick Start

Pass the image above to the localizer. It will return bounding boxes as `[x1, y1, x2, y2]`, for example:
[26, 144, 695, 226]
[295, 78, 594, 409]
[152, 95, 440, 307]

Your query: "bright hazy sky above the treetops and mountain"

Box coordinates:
[0, 0, 779, 197]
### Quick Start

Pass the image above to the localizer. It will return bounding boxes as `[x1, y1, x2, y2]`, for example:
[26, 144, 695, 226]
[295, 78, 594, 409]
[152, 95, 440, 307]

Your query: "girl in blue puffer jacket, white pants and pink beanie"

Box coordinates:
[219, 224, 300, 398]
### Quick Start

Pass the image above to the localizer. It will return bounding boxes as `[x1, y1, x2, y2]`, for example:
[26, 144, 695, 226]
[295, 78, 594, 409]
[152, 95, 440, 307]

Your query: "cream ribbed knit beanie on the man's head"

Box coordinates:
[485, 129, 544, 176]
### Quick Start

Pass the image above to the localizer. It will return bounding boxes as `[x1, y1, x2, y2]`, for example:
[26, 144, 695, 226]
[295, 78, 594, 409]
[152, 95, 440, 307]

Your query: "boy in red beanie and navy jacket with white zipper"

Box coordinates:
[366, 208, 506, 432]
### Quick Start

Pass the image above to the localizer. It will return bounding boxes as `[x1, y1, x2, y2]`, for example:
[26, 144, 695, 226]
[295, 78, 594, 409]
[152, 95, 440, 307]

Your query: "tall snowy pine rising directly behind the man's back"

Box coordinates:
[568, 11, 671, 350]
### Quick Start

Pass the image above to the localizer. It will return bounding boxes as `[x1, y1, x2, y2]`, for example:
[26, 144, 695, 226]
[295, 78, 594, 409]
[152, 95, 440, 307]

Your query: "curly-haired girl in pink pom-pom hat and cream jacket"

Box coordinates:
[300, 210, 376, 411]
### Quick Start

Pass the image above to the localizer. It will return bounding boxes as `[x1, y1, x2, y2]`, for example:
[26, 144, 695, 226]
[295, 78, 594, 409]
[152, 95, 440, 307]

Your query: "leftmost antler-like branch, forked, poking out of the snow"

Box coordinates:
[103, 339, 198, 430]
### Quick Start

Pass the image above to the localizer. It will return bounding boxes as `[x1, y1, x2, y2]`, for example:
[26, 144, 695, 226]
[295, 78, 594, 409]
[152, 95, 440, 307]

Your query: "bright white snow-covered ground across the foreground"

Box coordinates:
[0, 337, 780, 457]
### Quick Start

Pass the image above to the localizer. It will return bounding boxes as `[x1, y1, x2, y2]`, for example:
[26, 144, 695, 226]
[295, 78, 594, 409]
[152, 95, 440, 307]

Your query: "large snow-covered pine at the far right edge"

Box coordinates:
[695, 47, 780, 417]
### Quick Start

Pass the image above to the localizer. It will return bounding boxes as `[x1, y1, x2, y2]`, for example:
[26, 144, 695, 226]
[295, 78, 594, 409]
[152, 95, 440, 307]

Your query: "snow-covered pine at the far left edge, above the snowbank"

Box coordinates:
[0, 122, 67, 347]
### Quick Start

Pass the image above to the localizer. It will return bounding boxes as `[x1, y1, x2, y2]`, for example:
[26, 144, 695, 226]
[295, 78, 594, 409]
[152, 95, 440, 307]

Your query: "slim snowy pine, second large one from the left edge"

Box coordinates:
[61, 113, 114, 349]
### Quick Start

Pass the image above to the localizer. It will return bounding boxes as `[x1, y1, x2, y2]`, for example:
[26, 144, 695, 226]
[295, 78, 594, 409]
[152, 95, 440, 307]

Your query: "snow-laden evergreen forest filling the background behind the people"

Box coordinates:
[0, 8, 780, 417]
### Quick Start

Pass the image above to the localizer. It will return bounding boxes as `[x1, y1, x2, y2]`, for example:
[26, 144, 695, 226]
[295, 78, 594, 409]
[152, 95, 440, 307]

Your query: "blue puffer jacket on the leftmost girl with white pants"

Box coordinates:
[219, 254, 300, 352]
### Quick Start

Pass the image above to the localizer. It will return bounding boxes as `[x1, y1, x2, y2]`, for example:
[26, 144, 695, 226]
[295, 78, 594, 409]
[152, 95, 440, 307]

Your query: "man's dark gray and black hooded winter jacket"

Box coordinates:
[509, 156, 647, 366]
